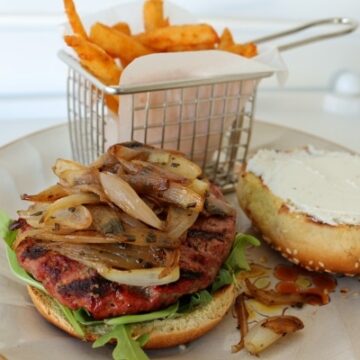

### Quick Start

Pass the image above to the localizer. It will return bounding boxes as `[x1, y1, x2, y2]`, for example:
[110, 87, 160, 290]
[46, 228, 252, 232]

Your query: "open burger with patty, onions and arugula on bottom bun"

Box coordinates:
[0, 142, 258, 359]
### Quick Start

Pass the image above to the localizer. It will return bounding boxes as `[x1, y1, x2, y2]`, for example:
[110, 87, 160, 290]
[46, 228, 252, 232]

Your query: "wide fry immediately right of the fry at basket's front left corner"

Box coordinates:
[90, 23, 152, 66]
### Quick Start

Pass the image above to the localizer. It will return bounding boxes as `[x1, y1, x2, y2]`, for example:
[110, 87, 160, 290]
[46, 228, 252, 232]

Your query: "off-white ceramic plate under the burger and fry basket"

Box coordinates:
[0, 122, 360, 360]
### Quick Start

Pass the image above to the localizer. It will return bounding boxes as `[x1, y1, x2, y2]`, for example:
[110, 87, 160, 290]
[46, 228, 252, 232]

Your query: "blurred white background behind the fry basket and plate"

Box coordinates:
[0, 0, 360, 150]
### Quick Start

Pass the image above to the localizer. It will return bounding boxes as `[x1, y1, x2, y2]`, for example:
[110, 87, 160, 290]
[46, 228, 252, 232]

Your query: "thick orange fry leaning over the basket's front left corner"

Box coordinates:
[64, 35, 121, 85]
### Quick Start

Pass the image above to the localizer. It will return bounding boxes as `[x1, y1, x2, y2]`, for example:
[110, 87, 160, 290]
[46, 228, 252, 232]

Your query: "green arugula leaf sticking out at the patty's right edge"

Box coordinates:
[225, 234, 260, 273]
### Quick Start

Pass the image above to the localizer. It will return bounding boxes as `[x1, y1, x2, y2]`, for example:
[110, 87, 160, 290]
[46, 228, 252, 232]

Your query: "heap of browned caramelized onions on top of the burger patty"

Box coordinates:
[13, 142, 234, 286]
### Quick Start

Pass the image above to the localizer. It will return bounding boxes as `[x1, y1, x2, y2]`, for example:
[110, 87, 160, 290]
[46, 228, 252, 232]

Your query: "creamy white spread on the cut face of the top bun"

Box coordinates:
[247, 147, 360, 225]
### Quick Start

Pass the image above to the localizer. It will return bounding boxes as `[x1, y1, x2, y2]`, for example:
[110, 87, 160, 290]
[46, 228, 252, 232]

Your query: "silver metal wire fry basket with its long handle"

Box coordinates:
[59, 18, 357, 191]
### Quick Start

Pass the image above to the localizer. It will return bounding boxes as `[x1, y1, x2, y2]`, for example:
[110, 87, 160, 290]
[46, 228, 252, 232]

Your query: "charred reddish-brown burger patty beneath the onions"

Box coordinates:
[16, 210, 235, 319]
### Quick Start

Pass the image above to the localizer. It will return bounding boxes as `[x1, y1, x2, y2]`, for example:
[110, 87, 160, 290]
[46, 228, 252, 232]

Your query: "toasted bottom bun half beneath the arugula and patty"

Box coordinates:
[27, 285, 236, 349]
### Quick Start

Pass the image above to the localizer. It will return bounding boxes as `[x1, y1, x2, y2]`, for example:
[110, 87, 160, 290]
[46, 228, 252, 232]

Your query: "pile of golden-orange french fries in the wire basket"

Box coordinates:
[64, 0, 257, 112]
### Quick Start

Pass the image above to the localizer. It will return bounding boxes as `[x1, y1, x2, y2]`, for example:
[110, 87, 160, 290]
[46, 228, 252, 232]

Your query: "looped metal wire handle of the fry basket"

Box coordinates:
[251, 17, 358, 51]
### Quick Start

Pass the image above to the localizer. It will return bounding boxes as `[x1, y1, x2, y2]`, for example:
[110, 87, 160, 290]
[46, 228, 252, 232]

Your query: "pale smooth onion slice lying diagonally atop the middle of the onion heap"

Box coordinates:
[100, 173, 163, 229]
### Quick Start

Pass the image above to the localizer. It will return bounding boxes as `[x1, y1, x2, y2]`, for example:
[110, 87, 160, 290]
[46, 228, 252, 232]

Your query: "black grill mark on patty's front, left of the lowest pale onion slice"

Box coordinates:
[58, 276, 111, 296]
